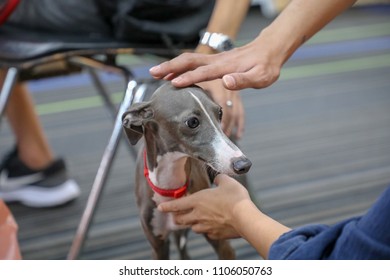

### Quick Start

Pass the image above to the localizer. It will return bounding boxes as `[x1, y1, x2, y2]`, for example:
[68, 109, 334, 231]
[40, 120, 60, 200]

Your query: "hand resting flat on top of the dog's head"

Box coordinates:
[150, 33, 285, 90]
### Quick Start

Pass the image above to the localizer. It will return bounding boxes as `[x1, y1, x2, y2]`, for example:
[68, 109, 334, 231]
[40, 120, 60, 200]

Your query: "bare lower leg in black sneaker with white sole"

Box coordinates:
[0, 71, 80, 207]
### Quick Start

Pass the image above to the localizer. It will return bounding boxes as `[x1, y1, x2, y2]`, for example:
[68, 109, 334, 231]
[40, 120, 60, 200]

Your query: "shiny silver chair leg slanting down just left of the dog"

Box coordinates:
[67, 80, 137, 260]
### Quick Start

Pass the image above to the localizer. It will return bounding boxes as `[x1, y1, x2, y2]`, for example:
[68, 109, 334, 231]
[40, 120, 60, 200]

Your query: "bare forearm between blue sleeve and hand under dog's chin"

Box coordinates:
[233, 201, 290, 259]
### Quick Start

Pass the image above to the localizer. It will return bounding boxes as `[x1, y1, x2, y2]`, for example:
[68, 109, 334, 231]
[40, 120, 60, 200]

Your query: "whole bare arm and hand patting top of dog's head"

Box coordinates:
[150, 0, 356, 90]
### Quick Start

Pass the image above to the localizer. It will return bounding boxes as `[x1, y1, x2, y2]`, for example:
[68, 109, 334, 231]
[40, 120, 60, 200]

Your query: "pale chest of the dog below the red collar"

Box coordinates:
[151, 193, 186, 239]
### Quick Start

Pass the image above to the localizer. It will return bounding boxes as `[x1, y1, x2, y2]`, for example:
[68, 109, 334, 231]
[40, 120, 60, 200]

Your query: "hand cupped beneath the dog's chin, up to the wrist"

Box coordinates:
[158, 174, 250, 239]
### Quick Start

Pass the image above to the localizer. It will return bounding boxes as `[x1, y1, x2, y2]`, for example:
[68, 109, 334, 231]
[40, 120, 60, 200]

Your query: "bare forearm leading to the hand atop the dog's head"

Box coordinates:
[256, 0, 356, 64]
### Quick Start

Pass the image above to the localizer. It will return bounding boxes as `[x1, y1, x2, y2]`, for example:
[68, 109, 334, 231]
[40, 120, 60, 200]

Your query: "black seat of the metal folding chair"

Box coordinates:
[0, 27, 194, 63]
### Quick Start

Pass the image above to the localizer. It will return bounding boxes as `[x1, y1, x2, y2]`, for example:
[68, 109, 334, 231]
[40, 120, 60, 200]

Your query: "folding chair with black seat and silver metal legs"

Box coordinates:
[0, 23, 194, 259]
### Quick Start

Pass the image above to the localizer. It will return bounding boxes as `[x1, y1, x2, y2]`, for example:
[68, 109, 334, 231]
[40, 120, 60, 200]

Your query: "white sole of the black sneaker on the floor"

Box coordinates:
[0, 179, 80, 208]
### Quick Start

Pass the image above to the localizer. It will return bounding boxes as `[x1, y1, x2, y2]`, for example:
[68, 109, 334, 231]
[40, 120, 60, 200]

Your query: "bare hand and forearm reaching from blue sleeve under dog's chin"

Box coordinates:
[159, 175, 290, 258]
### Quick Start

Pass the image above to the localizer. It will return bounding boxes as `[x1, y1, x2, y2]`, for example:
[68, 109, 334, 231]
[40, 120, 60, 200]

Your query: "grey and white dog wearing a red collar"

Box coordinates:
[122, 83, 251, 259]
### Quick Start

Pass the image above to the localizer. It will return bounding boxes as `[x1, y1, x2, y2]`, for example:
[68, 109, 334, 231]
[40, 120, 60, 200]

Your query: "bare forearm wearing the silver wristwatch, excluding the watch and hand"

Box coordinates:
[196, 0, 250, 53]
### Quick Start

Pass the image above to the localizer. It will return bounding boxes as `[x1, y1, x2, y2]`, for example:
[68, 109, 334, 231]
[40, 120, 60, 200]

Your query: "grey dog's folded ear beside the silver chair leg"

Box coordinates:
[122, 102, 154, 145]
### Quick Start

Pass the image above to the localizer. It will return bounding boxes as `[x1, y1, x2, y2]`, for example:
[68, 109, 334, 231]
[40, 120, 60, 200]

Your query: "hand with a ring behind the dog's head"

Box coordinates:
[198, 80, 245, 140]
